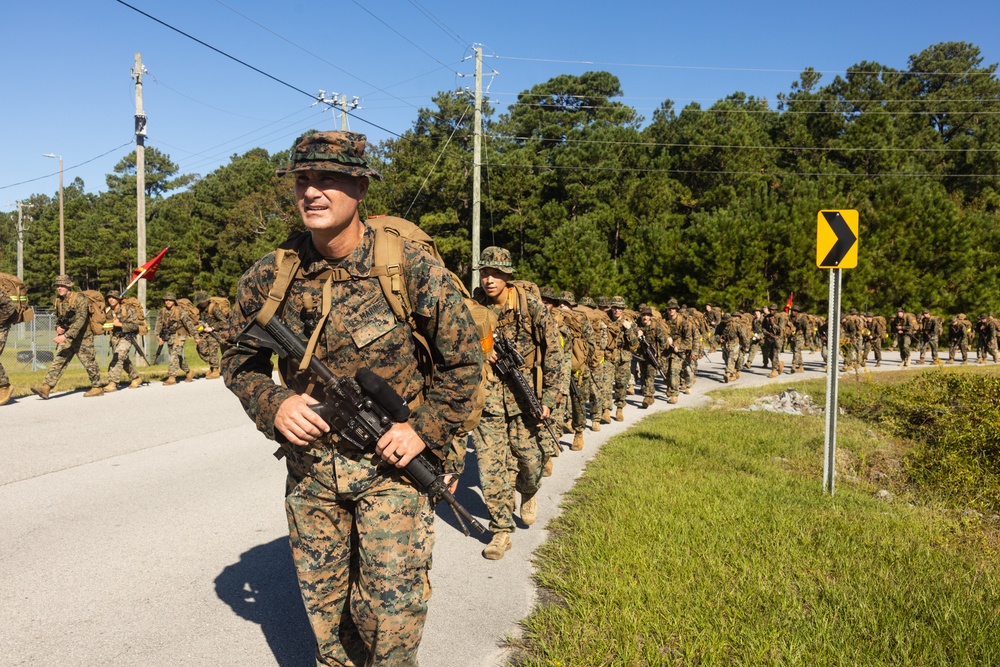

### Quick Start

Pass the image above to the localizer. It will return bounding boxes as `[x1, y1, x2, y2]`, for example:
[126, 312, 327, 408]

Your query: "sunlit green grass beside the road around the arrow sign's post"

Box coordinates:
[512, 371, 1000, 667]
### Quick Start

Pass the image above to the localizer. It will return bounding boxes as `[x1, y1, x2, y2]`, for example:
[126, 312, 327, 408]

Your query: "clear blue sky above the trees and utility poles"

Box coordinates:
[0, 0, 1000, 211]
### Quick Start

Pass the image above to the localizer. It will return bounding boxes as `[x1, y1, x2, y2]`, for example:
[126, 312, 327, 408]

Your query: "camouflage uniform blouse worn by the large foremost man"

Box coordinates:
[222, 224, 483, 470]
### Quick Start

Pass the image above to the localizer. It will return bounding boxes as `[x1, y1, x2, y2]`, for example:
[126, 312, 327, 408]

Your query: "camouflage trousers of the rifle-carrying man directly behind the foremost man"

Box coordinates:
[472, 412, 549, 533]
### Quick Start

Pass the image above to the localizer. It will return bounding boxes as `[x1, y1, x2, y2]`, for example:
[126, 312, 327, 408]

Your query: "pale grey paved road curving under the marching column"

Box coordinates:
[0, 353, 908, 667]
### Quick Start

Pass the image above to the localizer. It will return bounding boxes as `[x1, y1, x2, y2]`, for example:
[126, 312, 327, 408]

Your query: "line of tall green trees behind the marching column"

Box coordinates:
[0, 42, 1000, 320]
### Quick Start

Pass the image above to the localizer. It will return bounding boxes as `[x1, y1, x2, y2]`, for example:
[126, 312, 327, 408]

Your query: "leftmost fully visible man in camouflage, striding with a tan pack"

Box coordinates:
[31, 276, 104, 398]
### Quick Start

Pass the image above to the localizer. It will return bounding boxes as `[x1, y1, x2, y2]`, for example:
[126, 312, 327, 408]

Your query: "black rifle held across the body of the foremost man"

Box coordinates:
[236, 317, 486, 535]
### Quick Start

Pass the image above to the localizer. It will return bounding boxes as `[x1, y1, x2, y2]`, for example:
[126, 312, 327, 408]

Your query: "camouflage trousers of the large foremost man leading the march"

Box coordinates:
[285, 464, 434, 667]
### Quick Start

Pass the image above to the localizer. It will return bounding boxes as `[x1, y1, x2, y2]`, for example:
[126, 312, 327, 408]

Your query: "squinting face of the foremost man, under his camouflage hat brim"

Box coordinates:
[295, 169, 368, 235]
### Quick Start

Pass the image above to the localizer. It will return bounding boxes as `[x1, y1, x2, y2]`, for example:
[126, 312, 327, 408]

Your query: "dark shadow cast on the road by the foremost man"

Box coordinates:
[215, 537, 316, 667]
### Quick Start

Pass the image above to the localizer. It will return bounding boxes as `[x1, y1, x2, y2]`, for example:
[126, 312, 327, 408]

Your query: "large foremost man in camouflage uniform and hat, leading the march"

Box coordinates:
[222, 132, 482, 667]
